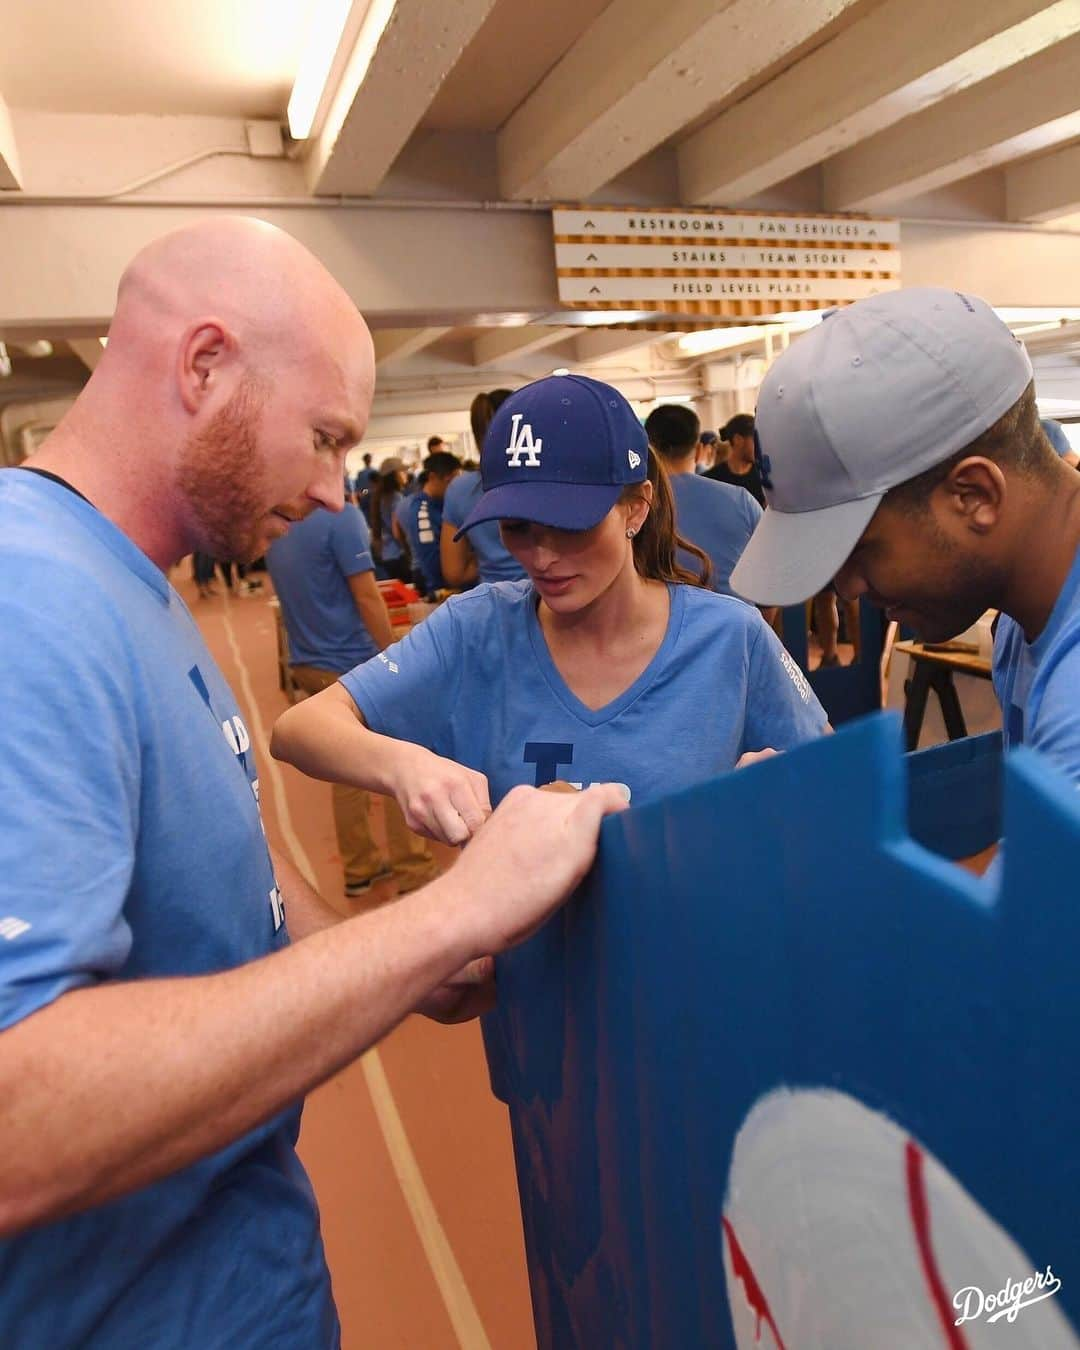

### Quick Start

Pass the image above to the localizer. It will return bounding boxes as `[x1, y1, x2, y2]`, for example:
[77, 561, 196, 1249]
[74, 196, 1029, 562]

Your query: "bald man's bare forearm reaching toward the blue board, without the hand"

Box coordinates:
[0, 873, 481, 1237]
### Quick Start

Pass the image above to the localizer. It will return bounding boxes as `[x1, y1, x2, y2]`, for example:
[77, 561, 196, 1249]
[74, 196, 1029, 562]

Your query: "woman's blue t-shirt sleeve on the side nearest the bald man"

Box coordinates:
[342, 599, 464, 757]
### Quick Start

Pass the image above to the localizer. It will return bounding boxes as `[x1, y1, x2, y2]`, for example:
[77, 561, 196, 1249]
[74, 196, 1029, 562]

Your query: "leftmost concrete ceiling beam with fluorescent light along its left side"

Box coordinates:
[306, 0, 494, 197]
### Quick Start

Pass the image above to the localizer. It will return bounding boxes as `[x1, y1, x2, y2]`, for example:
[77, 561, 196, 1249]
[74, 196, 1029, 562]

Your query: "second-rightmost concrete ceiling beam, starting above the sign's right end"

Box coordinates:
[824, 34, 1080, 211]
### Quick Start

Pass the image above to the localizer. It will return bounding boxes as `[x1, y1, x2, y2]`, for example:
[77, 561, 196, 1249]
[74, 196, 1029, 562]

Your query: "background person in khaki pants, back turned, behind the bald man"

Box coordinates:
[266, 504, 437, 899]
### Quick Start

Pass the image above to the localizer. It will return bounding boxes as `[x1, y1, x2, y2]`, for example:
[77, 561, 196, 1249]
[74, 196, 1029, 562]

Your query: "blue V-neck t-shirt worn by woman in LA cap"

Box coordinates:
[342, 582, 826, 803]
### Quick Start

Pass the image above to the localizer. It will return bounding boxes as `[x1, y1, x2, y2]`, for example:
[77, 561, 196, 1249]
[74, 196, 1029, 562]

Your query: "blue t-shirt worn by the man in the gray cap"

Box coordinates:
[994, 542, 1080, 787]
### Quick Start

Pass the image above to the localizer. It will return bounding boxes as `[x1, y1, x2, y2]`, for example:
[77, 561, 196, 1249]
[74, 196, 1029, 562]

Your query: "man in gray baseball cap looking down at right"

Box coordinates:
[732, 289, 1080, 784]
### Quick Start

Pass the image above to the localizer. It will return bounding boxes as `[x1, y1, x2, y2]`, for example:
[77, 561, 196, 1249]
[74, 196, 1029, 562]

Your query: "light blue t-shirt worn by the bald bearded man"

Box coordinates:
[0, 468, 339, 1350]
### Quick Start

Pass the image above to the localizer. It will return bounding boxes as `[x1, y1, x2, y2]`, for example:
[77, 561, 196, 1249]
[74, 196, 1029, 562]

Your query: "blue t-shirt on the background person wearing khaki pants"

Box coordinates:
[266, 504, 378, 675]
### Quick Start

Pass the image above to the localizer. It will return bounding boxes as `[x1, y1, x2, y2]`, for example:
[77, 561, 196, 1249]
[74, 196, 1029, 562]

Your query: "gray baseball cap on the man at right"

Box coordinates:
[732, 286, 1033, 605]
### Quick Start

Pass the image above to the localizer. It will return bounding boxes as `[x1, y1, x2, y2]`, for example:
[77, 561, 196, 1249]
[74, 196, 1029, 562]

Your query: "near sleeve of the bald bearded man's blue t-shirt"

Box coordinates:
[0, 559, 140, 1029]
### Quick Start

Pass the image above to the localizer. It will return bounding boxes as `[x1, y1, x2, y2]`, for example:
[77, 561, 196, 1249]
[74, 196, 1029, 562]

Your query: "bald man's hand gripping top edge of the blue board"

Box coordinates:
[448, 783, 626, 954]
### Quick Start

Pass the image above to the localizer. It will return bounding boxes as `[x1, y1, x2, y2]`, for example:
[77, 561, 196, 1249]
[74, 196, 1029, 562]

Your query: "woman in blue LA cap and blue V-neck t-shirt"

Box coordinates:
[271, 375, 826, 844]
